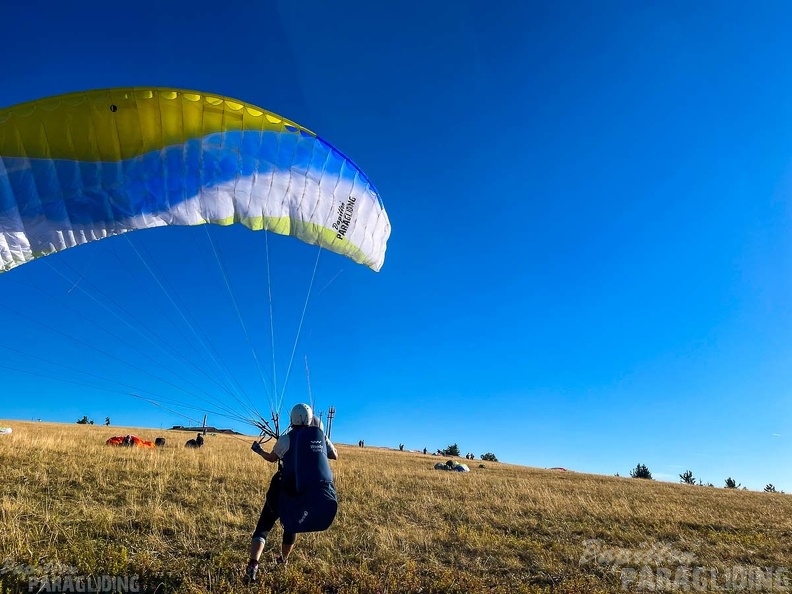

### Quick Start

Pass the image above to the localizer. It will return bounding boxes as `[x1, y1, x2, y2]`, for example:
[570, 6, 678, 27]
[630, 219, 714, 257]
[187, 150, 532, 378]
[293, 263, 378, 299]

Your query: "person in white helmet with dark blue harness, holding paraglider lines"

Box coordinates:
[243, 404, 338, 584]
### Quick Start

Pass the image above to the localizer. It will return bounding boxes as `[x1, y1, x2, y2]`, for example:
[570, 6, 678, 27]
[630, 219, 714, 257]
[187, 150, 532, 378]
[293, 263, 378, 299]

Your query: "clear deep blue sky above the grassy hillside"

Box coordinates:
[0, 1, 792, 491]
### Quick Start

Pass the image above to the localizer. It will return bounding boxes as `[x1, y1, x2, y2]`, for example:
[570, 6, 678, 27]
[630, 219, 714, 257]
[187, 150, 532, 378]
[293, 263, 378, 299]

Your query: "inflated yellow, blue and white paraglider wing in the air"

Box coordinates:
[0, 88, 390, 272]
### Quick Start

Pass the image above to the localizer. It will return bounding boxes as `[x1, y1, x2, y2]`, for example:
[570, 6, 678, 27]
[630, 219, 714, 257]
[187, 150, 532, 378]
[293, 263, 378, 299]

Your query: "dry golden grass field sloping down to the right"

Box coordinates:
[0, 421, 792, 594]
